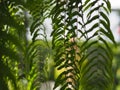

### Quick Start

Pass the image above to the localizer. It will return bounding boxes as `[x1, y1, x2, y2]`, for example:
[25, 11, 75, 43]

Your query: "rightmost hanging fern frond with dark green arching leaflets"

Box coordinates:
[80, 0, 115, 90]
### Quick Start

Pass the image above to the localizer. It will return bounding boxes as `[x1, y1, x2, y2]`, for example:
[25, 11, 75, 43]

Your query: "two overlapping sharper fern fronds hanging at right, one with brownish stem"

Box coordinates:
[51, 0, 115, 90]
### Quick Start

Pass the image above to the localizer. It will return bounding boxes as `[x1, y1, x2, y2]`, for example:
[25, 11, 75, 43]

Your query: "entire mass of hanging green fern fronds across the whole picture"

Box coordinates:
[0, 0, 115, 90]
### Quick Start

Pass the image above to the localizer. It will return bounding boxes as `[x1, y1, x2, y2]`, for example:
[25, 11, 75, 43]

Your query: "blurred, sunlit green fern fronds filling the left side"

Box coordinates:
[0, 0, 50, 90]
